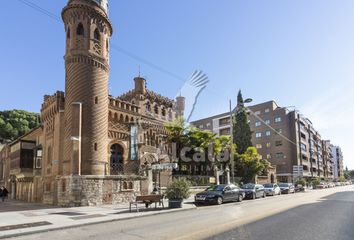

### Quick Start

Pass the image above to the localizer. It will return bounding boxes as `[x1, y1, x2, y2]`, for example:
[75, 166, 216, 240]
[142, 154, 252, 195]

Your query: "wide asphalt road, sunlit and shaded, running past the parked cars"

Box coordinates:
[11, 186, 354, 240]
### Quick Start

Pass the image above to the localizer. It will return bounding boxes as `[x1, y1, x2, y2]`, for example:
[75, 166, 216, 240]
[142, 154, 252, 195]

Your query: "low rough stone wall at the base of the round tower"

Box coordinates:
[57, 176, 147, 206]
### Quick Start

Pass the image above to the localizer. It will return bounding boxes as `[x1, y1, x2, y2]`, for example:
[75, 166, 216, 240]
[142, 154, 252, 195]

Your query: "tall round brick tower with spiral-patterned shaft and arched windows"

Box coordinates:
[62, 0, 112, 175]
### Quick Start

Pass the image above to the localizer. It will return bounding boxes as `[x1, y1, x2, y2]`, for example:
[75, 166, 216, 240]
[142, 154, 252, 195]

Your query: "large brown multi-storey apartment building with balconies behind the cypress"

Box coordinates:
[192, 101, 333, 182]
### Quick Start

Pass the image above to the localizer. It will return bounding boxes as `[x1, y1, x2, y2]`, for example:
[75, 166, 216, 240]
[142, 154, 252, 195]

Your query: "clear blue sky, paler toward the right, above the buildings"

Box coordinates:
[0, 0, 354, 169]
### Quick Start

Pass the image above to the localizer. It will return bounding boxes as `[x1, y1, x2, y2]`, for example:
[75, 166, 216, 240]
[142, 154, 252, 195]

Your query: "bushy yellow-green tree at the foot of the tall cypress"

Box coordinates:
[235, 147, 268, 183]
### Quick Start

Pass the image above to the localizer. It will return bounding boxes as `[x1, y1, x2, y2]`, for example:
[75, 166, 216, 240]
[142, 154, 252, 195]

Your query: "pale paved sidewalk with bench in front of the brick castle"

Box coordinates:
[0, 198, 196, 238]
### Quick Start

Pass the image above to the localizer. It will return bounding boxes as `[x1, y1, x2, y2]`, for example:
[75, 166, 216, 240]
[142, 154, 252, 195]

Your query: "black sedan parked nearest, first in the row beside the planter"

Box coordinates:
[195, 184, 244, 205]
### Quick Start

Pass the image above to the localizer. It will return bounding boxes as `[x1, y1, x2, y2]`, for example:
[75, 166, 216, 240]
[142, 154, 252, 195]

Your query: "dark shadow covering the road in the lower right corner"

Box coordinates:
[207, 192, 354, 240]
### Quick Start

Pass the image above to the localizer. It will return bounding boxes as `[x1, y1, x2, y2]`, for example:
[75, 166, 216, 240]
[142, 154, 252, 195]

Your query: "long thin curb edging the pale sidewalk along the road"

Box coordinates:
[0, 207, 198, 239]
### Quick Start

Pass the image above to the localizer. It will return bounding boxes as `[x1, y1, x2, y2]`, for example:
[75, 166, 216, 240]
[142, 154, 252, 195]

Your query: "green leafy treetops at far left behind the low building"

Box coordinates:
[0, 110, 39, 140]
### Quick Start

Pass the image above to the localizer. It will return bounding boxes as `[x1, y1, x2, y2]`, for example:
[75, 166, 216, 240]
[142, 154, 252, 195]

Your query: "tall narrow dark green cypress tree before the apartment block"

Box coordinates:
[232, 90, 252, 154]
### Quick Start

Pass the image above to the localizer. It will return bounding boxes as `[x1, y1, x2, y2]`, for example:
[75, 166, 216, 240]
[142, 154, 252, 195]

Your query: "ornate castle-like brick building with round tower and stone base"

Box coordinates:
[0, 0, 183, 206]
